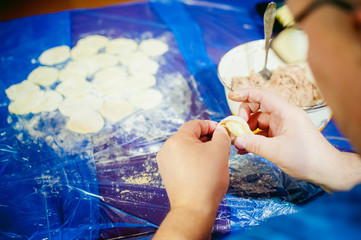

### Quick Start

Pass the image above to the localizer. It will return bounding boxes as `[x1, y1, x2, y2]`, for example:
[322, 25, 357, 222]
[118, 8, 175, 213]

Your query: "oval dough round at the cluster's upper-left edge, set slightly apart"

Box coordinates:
[39, 46, 70, 65]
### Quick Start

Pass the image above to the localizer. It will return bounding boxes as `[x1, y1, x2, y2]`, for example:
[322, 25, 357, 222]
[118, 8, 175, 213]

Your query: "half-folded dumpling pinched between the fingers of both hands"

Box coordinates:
[219, 116, 253, 142]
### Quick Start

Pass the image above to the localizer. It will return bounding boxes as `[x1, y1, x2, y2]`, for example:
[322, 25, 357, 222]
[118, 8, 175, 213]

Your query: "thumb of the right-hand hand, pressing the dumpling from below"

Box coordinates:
[234, 134, 277, 159]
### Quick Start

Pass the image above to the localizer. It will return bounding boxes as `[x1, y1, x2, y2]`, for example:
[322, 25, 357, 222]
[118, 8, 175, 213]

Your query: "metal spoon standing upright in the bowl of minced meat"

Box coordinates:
[259, 2, 276, 80]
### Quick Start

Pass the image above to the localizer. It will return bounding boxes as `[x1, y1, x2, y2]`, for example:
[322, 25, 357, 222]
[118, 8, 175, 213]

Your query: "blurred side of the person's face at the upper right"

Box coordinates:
[287, 0, 361, 154]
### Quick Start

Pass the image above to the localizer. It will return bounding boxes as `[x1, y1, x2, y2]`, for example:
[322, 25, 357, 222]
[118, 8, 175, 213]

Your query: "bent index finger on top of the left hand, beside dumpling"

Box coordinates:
[176, 120, 218, 139]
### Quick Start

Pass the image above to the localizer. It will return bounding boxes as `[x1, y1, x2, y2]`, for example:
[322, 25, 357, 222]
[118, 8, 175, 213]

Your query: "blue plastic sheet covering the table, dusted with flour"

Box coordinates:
[0, 0, 352, 239]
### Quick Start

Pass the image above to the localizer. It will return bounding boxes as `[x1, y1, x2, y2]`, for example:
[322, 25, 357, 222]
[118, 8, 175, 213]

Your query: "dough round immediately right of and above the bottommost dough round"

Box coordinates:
[100, 99, 134, 122]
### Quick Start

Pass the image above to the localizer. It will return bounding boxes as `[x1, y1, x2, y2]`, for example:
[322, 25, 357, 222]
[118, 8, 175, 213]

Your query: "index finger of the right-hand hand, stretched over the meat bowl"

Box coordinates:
[228, 89, 289, 113]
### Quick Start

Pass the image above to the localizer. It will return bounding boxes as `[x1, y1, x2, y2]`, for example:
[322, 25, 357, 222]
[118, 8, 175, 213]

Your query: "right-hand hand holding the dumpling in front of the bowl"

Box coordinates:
[229, 89, 349, 191]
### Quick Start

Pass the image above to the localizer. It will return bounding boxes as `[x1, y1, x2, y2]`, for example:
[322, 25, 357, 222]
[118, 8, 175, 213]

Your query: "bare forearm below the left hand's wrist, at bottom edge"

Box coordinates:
[154, 208, 217, 239]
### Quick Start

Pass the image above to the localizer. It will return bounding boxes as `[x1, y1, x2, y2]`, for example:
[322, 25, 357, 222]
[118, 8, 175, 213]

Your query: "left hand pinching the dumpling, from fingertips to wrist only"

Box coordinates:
[157, 120, 230, 212]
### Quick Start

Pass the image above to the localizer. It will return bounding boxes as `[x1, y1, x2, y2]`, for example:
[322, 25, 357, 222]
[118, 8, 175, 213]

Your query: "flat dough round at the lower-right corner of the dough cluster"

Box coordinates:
[130, 89, 163, 109]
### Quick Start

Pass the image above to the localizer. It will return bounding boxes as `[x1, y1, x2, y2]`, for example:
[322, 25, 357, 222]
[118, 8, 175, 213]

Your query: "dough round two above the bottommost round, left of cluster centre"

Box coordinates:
[55, 80, 93, 98]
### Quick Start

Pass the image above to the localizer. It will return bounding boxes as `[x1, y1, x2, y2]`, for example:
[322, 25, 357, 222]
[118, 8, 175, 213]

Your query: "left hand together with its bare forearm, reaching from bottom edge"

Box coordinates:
[154, 121, 231, 239]
